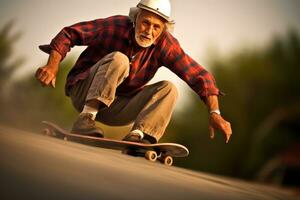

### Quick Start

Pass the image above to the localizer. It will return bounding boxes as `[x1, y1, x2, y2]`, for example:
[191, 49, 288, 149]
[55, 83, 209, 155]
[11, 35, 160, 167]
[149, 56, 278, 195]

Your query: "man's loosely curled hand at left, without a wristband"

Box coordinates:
[35, 65, 58, 88]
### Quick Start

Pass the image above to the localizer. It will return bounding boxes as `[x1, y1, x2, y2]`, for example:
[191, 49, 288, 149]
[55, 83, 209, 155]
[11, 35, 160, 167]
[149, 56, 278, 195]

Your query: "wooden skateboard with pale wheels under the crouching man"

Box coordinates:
[42, 121, 189, 166]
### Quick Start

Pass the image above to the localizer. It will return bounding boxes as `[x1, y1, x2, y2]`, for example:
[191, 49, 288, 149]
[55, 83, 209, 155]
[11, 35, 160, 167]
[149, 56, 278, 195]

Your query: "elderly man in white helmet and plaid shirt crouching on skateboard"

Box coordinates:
[36, 0, 231, 143]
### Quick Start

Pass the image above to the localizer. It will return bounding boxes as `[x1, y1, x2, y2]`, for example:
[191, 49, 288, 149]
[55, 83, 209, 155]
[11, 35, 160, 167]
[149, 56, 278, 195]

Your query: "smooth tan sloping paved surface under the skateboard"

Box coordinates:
[0, 126, 300, 200]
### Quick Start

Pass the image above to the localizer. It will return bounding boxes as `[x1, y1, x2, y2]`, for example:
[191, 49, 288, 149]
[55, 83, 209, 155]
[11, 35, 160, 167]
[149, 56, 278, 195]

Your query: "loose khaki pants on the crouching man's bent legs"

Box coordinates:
[70, 52, 178, 141]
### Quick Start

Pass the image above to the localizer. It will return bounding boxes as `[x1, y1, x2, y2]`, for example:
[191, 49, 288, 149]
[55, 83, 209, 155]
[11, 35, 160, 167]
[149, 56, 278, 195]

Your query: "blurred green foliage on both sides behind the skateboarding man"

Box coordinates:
[0, 23, 300, 181]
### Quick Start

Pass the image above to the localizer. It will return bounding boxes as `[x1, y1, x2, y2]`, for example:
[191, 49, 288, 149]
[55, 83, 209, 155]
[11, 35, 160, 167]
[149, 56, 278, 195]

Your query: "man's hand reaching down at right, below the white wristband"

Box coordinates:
[208, 113, 232, 143]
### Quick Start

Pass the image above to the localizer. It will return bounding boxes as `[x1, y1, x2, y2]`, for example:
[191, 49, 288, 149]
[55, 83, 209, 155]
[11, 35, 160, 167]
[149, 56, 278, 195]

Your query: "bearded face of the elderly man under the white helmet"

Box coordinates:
[135, 10, 165, 48]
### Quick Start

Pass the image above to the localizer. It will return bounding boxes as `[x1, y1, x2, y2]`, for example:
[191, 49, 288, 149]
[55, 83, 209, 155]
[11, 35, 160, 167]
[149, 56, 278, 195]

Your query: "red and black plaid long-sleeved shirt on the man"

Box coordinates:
[40, 16, 220, 99]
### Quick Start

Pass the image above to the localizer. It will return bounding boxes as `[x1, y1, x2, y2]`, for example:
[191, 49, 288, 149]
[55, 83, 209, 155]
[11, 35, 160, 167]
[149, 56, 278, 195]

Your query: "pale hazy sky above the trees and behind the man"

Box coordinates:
[0, 0, 300, 109]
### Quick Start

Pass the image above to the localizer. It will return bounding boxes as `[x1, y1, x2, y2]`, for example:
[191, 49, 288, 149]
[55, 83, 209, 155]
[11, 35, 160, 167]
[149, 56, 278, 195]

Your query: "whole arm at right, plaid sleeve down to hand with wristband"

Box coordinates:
[159, 32, 232, 143]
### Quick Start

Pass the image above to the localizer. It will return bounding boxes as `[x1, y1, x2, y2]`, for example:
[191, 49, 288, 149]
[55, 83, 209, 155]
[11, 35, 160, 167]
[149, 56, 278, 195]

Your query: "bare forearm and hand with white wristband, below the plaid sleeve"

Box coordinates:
[206, 95, 232, 143]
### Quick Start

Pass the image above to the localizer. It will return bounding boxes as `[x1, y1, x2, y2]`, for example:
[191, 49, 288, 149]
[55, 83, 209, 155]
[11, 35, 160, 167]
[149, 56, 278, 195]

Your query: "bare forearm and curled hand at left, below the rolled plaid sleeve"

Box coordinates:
[35, 50, 62, 88]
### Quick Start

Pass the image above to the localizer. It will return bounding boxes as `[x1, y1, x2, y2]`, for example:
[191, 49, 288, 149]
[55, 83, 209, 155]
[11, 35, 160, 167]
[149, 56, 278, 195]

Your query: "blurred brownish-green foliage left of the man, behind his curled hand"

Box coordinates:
[0, 22, 75, 130]
